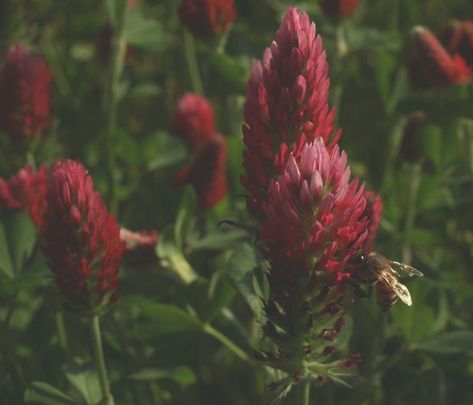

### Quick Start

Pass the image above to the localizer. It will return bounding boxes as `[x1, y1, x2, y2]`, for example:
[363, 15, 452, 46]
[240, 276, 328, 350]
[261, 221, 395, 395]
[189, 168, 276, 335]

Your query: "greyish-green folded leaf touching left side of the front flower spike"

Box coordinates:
[226, 243, 264, 320]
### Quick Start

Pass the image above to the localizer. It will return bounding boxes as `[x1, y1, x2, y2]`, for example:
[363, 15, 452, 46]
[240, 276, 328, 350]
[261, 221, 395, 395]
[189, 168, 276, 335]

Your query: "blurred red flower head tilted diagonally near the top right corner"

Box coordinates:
[410, 26, 472, 88]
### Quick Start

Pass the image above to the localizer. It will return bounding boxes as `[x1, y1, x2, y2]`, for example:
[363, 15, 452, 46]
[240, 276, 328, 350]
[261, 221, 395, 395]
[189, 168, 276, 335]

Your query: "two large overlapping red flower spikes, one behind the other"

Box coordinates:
[242, 8, 370, 392]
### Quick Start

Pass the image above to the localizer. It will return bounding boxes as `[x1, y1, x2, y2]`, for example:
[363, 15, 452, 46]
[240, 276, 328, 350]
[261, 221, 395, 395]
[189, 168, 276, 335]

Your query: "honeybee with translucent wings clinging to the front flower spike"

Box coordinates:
[354, 252, 424, 311]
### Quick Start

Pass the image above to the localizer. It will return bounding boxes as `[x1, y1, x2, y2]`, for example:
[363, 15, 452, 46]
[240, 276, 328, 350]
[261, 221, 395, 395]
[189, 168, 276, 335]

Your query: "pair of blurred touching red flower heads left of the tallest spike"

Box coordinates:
[173, 94, 228, 210]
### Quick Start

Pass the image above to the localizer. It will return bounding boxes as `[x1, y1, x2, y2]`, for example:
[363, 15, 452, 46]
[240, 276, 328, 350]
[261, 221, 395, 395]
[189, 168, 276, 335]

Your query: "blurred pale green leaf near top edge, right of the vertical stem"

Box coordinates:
[124, 8, 173, 51]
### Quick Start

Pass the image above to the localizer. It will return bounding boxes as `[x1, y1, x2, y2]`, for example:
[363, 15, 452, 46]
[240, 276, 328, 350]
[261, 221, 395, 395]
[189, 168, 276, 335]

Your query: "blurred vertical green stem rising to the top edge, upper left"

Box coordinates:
[105, 3, 126, 213]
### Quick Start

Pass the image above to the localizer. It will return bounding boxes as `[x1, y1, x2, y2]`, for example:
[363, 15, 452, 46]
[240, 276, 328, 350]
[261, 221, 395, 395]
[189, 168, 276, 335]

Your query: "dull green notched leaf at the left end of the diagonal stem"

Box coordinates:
[125, 297, 202, 339]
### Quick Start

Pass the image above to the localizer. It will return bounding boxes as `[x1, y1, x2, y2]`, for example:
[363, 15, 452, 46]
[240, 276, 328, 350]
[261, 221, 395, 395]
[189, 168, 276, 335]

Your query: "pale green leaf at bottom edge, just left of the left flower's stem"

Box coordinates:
[64, 361, 102, 405]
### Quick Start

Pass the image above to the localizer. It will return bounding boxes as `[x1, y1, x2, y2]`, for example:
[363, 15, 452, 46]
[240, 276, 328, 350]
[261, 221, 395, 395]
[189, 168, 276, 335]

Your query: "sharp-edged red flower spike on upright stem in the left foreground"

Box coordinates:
[42, 160, 125, 314]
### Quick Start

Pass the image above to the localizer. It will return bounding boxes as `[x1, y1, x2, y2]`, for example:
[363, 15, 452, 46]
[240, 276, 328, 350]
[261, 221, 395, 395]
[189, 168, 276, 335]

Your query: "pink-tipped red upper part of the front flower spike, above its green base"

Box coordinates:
[260, 138, 368, 288]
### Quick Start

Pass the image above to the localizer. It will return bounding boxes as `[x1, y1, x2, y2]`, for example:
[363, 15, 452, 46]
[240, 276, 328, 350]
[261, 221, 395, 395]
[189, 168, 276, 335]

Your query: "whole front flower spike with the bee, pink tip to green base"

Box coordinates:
[258, 138, 368, 385]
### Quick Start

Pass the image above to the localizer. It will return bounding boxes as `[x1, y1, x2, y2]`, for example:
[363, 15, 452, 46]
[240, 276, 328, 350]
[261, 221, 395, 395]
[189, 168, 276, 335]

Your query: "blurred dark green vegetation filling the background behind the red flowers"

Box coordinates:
[0, 0, 473, 405]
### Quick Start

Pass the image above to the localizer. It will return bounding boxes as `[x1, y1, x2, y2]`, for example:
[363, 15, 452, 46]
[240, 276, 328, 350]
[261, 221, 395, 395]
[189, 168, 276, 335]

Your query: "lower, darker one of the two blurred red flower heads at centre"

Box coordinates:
[176, 133, 228, 210]
